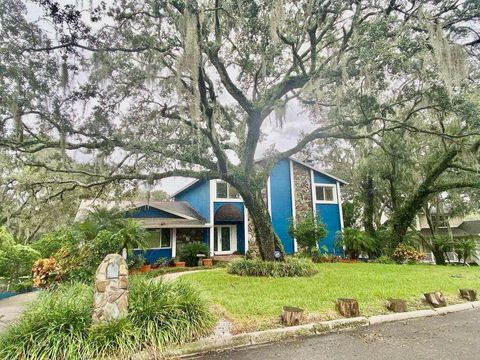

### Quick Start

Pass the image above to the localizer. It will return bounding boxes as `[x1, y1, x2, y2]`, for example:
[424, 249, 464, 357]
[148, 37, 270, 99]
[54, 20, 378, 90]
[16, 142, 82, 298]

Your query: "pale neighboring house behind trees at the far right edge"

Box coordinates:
[417, 208, 480, 264]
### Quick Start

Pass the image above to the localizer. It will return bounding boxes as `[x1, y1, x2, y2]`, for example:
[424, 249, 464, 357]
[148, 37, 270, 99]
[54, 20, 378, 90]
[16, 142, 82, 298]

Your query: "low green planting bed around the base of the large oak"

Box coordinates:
[228, 258, 317, 277]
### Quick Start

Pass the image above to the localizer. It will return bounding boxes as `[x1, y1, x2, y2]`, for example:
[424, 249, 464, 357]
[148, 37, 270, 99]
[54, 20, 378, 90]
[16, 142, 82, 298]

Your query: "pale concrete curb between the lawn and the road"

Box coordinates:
[165, 301, 480, 357]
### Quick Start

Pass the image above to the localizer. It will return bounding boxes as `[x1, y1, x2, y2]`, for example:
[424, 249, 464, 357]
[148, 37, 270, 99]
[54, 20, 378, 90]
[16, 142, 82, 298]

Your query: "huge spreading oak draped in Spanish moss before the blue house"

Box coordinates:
[0, 0, 479, 260]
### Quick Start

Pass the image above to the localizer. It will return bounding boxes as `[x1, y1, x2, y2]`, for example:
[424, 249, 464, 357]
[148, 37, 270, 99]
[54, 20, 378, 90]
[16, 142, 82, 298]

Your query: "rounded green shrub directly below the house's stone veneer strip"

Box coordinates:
[288, 214, 327, 253]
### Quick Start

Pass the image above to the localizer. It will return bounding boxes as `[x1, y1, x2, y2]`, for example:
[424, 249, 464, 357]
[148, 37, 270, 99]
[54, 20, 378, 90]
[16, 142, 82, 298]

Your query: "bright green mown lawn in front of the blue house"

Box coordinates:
[184, 263, 480, 331]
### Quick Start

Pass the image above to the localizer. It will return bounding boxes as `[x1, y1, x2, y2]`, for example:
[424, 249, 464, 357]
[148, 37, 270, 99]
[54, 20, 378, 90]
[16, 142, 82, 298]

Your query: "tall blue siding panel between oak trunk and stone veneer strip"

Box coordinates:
[270, 160, 294, 254]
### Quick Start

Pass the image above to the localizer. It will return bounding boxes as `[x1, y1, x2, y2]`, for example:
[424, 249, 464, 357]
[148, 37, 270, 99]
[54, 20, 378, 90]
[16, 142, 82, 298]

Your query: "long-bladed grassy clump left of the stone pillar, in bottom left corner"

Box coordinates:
[0, 284, 93, 360]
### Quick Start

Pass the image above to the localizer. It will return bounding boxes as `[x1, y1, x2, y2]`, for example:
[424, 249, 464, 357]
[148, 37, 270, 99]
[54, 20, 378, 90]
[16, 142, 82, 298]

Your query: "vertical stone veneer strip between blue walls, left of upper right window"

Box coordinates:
[293, 162, 313, 220]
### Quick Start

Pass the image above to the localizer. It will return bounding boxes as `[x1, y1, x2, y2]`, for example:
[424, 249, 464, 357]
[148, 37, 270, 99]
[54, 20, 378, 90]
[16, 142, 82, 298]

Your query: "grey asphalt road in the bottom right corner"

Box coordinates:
[193, 309, 480, 360]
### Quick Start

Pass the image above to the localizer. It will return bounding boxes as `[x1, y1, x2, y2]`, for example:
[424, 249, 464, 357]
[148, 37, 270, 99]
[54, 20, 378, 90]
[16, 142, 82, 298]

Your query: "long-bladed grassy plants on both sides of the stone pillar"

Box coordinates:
[0, 276, 215, 360]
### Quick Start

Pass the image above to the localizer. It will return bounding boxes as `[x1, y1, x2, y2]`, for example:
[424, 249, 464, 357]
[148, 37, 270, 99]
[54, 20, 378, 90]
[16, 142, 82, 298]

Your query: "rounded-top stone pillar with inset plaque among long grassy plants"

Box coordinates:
[92, 254, 128, 323]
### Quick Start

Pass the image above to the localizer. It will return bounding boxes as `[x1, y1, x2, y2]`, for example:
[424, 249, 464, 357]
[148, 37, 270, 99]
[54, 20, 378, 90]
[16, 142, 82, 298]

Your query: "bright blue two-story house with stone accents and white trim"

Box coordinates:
[76, 159, 346, 262]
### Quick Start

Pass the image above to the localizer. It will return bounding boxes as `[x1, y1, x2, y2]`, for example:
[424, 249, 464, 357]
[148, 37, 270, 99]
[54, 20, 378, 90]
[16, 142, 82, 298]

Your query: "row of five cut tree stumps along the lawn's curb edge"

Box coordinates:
[282, 289, 477, 326]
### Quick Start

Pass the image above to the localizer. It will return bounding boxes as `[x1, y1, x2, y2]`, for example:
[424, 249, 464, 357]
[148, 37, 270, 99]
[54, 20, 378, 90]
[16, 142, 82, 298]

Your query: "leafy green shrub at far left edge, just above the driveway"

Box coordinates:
[0, 244, 40, 282]
